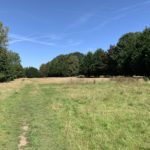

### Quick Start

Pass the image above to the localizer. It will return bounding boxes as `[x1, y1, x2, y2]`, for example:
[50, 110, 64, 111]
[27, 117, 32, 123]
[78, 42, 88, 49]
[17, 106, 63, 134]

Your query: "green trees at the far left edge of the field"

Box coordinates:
[0, 22, 23, 82]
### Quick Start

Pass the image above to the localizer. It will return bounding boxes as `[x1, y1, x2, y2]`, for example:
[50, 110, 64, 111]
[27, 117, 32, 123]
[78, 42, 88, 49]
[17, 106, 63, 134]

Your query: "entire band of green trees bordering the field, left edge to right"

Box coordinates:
[0, 22, 150, 82]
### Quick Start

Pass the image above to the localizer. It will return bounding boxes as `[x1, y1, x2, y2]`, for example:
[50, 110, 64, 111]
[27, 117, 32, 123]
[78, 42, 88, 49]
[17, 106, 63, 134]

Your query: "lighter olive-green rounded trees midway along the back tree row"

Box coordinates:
[45, 52, 84, 77]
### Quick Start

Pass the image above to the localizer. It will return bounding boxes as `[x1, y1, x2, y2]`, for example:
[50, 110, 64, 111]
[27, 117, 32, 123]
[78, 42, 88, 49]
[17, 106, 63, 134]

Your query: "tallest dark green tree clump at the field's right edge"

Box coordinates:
[107, 28, 150, 76]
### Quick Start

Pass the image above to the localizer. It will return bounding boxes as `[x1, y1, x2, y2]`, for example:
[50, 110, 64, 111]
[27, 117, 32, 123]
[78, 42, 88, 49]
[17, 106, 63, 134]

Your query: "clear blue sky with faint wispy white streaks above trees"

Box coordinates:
[0, 0, 150, 68]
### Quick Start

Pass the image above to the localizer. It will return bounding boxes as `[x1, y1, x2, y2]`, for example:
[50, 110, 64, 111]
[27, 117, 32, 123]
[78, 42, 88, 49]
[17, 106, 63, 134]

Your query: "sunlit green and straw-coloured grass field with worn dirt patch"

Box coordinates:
[0, 78, 150, 150]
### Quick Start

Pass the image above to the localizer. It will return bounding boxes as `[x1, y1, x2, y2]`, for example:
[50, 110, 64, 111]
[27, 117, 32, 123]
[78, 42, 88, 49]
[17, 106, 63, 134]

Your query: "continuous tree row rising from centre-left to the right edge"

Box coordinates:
[40, 28, 150, 77]
